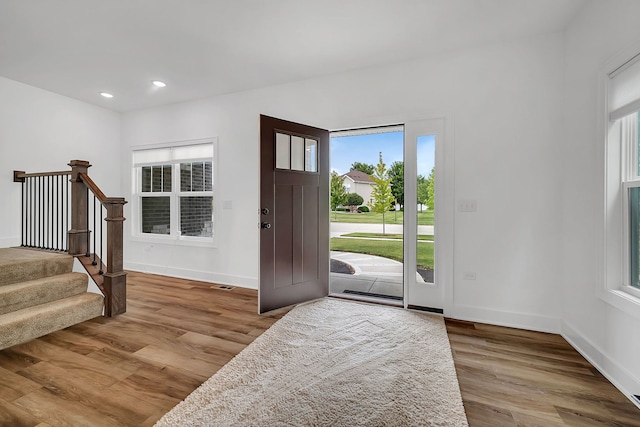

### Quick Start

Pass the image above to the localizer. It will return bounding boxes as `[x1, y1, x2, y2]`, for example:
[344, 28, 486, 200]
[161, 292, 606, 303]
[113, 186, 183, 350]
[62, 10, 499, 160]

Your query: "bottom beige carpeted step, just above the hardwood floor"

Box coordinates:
[0, 292, 104, 349]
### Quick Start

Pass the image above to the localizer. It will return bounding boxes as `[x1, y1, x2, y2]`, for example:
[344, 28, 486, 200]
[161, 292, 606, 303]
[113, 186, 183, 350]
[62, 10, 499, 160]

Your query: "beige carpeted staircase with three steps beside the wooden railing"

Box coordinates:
[0, 248, 104, 349]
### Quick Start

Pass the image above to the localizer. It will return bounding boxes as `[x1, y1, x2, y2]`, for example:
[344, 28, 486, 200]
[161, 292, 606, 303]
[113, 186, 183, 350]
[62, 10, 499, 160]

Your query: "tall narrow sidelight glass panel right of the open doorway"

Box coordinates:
[416, 135, 436, 285]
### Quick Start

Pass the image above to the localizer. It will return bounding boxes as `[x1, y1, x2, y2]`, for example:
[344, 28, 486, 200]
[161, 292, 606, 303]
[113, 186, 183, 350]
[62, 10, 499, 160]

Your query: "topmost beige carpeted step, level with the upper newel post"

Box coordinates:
[0, 248, 73, 286]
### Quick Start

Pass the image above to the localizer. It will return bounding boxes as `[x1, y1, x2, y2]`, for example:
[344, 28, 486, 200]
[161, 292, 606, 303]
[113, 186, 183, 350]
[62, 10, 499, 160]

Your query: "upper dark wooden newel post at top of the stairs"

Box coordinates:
[69, 160, 91, 255]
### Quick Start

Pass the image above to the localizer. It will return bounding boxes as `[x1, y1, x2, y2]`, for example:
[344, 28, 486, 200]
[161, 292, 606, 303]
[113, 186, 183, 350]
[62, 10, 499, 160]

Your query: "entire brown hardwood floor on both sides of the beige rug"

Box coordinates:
[0, 272, 640, 427]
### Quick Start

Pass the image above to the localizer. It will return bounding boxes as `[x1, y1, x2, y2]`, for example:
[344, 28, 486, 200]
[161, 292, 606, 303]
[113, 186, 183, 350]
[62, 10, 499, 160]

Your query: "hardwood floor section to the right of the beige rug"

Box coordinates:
[446, 319, 640, 427]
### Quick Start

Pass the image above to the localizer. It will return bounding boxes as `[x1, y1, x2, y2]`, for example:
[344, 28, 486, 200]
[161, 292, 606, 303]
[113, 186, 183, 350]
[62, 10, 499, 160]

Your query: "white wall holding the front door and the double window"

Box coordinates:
[122, 33, 563, 331]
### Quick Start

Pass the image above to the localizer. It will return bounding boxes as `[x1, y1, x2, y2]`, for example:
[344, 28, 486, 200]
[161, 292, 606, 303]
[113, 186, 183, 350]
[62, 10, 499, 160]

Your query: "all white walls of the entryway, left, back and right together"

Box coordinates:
[0, 0, 640, 402]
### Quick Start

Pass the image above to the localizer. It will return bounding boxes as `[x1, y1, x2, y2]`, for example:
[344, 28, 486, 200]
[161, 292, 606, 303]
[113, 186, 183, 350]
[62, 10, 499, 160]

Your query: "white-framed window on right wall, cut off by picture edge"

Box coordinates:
[607, 55, 640, 297]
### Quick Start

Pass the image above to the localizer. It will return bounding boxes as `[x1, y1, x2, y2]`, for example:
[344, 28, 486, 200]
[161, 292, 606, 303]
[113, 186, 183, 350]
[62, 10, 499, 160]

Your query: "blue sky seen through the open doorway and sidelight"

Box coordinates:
[330, 132, 435, 177]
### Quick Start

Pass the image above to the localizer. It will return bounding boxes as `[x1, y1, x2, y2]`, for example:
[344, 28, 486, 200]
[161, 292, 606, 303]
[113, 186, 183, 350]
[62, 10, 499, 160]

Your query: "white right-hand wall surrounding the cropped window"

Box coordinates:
[562, 0, 640, 404]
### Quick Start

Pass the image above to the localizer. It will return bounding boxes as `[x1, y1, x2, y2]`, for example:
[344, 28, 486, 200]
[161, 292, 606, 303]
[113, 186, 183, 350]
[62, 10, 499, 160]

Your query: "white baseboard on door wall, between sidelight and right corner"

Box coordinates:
[445, 305, 562, 334]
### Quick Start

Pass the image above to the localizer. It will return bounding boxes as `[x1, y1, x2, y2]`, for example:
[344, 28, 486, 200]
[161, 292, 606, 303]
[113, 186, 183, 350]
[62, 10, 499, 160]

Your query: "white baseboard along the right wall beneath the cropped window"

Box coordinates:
[561, 321, 640, 408]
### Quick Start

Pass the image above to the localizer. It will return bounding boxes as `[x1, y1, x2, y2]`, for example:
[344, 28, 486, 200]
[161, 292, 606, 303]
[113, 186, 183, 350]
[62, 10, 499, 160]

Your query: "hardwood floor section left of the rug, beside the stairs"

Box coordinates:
[0, 272, 288, 427]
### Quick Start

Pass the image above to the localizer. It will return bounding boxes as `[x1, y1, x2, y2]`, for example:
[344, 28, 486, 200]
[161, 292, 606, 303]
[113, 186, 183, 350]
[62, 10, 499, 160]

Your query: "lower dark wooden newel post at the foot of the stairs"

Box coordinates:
[103, 197, 127, 317]
